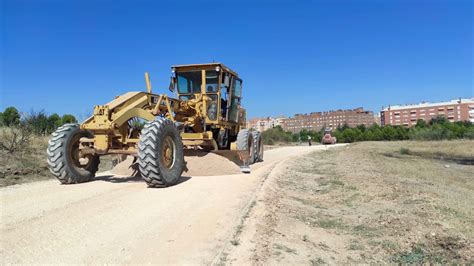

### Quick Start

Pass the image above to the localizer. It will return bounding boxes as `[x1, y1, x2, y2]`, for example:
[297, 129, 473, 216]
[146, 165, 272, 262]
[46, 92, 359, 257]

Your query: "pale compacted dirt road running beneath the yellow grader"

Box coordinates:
[0, 146, 340, 264]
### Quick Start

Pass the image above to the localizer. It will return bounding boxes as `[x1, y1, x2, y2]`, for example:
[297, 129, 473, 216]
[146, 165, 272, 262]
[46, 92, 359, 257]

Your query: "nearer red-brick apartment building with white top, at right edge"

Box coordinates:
[380, 98, 474, 127]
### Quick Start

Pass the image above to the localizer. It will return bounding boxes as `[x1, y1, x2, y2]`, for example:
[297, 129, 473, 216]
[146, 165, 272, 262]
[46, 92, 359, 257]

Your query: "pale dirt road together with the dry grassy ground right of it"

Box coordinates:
[0, 141, 474, 265]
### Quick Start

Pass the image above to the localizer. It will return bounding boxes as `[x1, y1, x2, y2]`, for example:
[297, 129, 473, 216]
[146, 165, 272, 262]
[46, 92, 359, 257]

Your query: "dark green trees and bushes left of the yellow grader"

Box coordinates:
[0, 106, 77, 135]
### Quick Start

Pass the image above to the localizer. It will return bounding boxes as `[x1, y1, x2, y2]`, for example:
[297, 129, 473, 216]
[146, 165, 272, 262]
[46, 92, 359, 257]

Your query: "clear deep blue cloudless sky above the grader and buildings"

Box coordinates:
[0, 0, 474, 118]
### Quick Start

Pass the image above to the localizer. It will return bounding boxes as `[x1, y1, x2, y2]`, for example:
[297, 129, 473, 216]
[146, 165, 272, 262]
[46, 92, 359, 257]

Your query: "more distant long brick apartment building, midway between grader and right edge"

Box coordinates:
[281, 107, 374, 133]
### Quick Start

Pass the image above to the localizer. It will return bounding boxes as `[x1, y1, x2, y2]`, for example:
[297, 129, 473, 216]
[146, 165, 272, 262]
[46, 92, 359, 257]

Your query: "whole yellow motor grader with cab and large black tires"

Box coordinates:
[47, 63, 263, 187]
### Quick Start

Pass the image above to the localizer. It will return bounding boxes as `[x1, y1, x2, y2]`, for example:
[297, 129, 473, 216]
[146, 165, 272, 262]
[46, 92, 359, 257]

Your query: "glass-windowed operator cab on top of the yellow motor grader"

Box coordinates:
[170, 63, 242, 123]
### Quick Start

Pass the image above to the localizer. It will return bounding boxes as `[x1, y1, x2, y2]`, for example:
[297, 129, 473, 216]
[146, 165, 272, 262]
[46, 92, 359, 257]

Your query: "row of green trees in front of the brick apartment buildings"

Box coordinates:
[262, 116, 474, 145]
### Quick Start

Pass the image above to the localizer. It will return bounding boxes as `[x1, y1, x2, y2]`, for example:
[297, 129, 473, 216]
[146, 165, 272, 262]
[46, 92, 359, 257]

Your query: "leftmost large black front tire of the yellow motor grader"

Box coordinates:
[46, 124, 100, 184]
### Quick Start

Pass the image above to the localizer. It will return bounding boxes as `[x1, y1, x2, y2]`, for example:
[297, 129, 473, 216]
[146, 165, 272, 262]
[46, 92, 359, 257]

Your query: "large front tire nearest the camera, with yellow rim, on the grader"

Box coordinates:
[138, 117, 184, 187]
